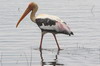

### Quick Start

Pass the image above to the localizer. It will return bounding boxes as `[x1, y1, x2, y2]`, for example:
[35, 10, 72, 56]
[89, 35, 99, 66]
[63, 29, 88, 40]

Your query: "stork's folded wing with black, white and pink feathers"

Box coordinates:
[36, 18, 71, 34]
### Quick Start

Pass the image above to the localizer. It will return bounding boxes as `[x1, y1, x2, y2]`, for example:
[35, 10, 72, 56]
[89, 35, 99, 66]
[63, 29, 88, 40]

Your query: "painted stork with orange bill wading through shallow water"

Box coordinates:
[16, 2, 73, 50]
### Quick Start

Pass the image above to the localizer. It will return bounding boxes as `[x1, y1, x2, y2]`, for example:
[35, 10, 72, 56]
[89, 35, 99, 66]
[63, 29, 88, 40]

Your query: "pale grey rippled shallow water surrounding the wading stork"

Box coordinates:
[0, 0, 100, 66]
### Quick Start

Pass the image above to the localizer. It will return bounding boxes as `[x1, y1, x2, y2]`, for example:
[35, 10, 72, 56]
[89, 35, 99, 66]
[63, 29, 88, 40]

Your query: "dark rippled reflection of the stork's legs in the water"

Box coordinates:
[40, 50, 64, 66]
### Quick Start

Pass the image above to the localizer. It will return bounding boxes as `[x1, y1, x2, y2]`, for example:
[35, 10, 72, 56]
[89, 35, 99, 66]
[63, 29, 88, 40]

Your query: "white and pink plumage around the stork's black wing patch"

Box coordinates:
[36, 14, 71, 33]
